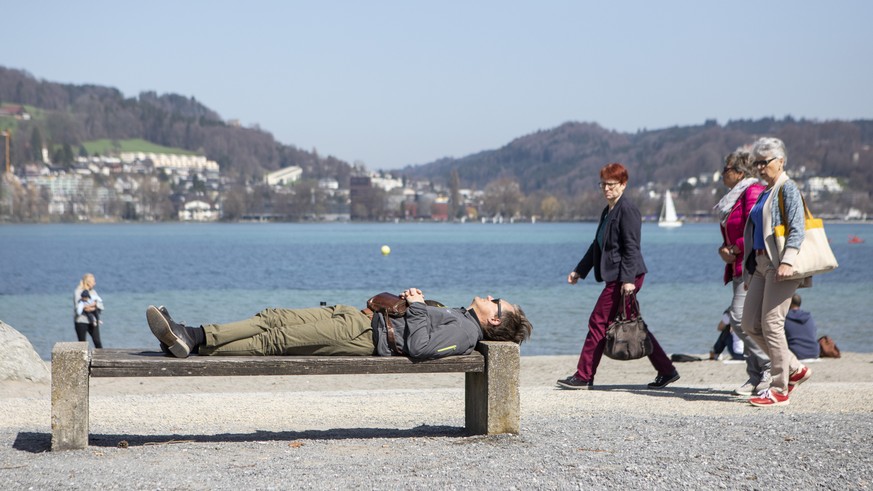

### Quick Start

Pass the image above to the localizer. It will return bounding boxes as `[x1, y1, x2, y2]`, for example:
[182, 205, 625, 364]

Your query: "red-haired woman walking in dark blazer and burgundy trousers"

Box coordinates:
[558, 163, 679, 389]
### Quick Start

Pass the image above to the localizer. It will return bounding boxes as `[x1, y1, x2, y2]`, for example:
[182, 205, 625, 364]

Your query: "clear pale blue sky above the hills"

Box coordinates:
[0, 0, 873, 169]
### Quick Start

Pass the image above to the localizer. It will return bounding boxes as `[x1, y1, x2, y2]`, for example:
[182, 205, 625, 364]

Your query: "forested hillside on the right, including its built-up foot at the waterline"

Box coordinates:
[403, 117, 873, 219]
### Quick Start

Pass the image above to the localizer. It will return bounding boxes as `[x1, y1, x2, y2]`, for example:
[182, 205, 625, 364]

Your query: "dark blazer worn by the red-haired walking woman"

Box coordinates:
[575, 196, 648, 283]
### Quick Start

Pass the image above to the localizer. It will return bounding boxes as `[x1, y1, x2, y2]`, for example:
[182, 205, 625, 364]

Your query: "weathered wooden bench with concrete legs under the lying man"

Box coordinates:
[51, 341, 520, 450]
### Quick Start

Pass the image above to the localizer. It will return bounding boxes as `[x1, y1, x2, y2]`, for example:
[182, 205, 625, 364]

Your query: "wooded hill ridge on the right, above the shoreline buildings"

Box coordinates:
[403, 117, 873, 197]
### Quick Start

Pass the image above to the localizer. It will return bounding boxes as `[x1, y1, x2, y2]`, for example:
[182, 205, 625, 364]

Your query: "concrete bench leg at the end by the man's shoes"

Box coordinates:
[52, 343, 91, 451]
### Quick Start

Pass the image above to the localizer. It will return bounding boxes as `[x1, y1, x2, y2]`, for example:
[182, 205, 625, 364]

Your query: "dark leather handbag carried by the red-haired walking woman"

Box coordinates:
[603, 292, 652, 360]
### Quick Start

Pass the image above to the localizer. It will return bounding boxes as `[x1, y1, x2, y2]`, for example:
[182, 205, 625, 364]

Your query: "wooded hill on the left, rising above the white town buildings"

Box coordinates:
[0, 66, 351, 182]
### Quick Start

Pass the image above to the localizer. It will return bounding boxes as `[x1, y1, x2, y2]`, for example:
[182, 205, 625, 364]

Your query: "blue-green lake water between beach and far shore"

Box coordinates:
[0, 223, 873, 359]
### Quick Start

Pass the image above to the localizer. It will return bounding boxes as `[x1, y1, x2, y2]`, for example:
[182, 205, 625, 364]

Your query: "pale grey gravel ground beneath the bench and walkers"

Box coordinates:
[0, 353, 873, 489]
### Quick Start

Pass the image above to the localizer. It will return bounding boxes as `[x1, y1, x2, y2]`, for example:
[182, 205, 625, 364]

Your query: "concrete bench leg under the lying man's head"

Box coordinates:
[465, 341, 521, 435]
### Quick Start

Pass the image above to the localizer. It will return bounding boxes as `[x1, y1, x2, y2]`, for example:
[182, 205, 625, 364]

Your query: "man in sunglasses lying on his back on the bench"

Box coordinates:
[146, 288, 533, 359]
